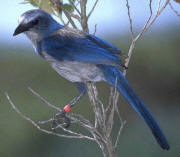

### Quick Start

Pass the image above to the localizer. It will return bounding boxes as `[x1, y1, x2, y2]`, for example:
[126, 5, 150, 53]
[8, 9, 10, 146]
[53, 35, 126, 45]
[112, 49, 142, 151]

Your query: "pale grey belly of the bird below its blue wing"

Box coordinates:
[51, 61, 104, 82]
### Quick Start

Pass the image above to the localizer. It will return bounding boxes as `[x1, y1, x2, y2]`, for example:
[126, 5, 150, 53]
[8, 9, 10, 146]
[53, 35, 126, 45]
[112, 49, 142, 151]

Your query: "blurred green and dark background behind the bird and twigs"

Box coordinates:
[0, 0, 180, 157]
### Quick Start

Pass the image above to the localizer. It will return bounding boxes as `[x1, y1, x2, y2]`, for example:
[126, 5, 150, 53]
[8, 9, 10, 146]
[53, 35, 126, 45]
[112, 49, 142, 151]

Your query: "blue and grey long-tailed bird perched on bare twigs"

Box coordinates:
[13, 9, 170, 150]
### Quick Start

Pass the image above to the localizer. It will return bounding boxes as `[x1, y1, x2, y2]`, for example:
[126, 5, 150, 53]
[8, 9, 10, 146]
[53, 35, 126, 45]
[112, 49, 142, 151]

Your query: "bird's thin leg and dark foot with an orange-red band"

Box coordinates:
[51, 83, 86, 131]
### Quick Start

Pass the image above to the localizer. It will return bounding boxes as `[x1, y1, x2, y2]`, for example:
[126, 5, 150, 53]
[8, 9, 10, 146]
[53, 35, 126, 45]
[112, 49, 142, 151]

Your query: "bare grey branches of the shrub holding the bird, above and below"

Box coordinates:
[8, 0, 173, 157]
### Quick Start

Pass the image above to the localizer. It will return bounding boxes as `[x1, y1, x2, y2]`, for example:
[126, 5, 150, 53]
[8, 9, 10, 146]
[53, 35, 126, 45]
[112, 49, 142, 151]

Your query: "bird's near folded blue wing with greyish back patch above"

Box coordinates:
[41, 28, 123, 66]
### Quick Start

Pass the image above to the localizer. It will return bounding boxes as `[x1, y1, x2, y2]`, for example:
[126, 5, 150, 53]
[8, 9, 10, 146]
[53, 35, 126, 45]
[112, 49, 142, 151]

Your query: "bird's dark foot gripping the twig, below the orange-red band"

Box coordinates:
[51, 109, 71, 132]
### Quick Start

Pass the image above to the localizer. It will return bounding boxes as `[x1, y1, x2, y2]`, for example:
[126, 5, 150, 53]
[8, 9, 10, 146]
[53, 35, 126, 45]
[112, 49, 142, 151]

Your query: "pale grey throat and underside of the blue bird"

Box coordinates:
[25, 32, 104, 82]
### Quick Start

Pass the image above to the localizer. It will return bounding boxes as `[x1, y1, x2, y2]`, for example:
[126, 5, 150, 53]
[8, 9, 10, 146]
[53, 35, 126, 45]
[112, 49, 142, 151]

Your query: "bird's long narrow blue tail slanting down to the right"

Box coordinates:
[98, 65, 169, 150]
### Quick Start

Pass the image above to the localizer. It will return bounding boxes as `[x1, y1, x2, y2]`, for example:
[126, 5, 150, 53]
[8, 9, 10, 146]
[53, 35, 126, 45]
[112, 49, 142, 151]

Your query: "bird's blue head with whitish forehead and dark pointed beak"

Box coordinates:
[13, 9, 62, 38]
